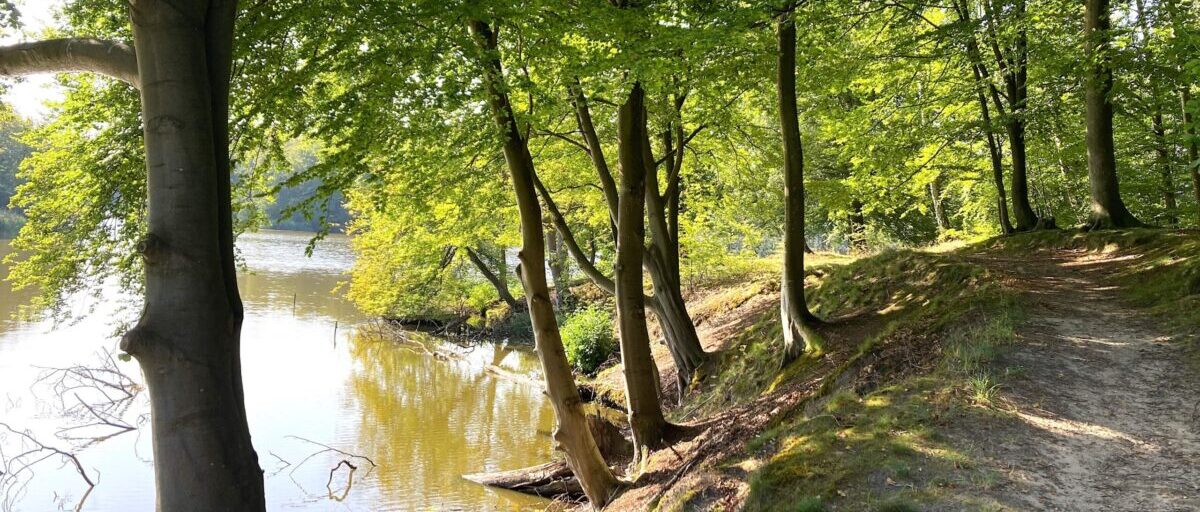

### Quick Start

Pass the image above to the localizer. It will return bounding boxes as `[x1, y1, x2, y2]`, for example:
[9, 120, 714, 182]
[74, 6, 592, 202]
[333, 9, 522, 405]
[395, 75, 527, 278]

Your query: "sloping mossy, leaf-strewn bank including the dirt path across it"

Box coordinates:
[585, 231, 1200, 512]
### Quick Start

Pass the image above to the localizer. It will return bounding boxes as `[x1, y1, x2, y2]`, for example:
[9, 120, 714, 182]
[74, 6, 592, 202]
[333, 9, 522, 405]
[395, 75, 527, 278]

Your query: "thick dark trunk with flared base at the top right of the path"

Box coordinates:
[1084, 0, 1141, 229]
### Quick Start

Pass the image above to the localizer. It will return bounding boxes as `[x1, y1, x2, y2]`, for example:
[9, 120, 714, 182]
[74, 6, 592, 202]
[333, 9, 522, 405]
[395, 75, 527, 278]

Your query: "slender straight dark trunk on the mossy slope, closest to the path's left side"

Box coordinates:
[775, 13, 824, 366]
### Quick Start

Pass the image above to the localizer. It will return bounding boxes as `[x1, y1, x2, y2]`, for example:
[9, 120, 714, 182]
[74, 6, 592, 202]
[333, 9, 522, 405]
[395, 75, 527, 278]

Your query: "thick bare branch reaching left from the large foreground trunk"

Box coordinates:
[0, 38, 142, 88]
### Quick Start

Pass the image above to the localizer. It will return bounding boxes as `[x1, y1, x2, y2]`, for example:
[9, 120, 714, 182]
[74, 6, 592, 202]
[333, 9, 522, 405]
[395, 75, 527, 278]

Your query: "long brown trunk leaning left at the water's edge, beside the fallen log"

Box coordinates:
[468, 20, 618, 508]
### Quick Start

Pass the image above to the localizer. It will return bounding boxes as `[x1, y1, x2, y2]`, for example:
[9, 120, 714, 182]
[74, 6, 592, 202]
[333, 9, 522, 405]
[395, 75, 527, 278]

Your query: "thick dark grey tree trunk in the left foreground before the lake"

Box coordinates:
[121, 0, 265, 511]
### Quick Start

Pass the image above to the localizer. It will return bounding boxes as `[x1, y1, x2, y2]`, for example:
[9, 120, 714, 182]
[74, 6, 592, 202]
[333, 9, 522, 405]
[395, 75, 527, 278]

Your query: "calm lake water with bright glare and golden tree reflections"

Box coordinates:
[0, 231, 553, 512]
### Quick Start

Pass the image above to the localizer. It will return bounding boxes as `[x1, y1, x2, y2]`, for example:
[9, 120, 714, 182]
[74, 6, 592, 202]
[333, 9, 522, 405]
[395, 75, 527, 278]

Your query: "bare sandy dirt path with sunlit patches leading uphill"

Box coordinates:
[977, 252, 1200, 511]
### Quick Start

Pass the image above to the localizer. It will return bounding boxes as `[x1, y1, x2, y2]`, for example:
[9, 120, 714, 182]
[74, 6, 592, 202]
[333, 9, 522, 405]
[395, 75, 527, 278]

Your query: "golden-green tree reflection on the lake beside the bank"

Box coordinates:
[349, 335, 553, 506]
